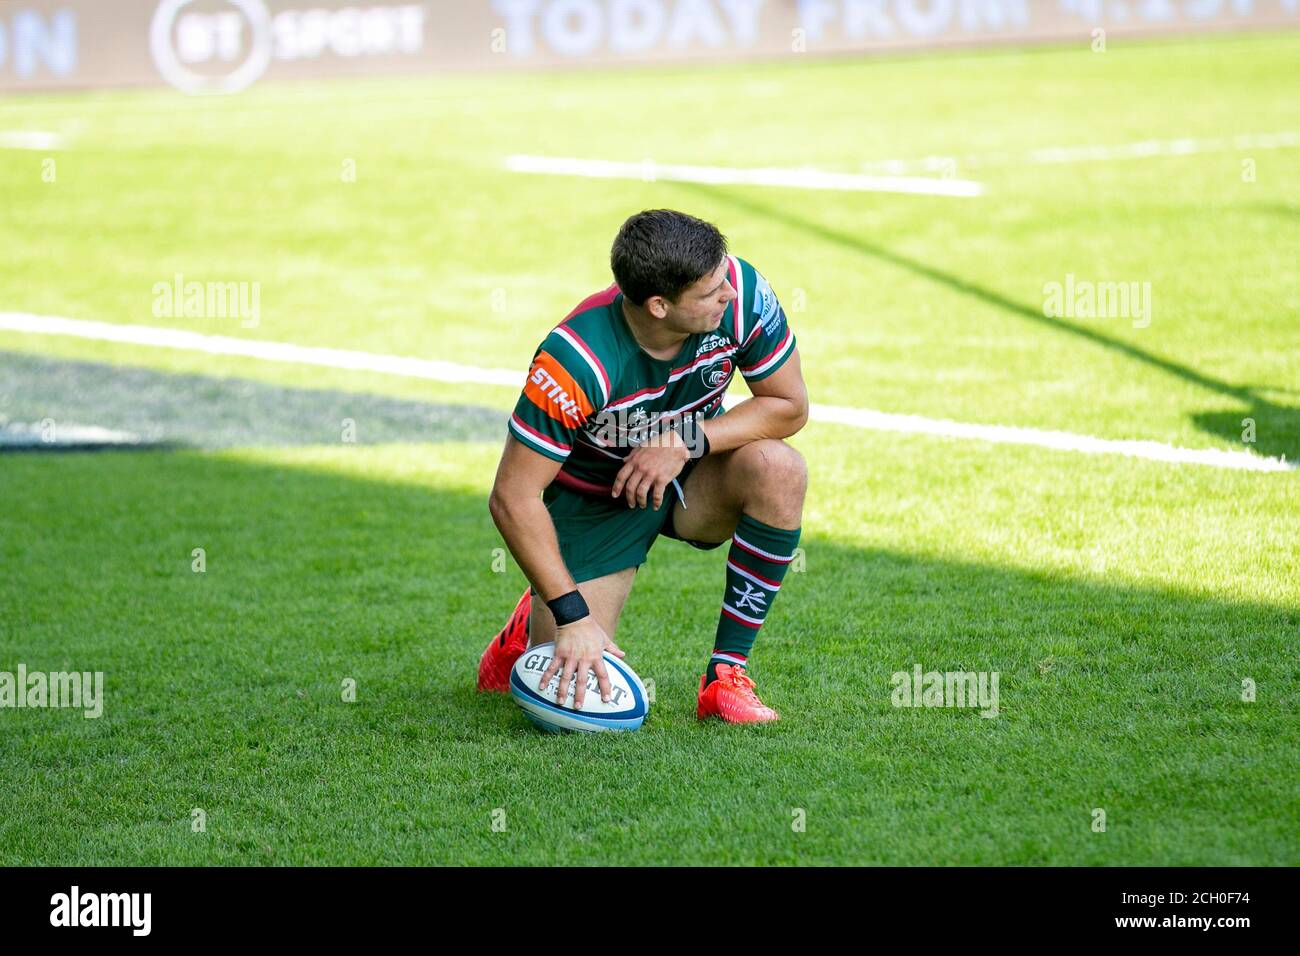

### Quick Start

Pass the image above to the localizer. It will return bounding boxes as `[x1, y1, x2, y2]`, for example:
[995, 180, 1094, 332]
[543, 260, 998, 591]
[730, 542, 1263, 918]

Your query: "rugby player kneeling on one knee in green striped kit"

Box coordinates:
[478, 209, 809, 723]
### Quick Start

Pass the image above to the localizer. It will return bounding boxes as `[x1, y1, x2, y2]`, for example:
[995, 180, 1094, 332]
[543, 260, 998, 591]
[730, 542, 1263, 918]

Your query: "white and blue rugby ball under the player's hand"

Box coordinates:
[510, 644, 650, 732]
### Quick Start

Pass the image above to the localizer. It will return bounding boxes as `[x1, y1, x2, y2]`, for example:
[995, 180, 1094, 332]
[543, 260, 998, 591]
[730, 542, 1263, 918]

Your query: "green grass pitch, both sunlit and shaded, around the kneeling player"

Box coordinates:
[0, 34, 1300, 865]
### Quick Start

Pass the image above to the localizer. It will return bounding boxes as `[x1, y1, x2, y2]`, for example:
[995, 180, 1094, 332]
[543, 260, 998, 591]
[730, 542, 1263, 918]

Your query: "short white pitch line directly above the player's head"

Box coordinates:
[506, 155, 984, 196]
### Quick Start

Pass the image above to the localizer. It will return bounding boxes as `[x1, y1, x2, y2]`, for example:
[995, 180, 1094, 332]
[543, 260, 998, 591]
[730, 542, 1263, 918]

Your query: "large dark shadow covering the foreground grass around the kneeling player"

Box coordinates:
[0, 445, 1300, 864]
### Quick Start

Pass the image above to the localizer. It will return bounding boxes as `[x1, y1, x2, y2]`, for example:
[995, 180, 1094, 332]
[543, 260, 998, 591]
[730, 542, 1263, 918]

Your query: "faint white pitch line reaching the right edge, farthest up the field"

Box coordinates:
[862, 130, 1300, 176]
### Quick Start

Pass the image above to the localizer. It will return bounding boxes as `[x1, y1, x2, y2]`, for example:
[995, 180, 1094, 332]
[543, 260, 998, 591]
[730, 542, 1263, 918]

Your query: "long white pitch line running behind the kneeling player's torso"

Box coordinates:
[0, 312, 1296, 472]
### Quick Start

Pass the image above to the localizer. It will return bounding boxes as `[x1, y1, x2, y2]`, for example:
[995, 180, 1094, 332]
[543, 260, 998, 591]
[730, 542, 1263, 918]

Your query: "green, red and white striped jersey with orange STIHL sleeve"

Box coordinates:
[508, 256, 794, 494]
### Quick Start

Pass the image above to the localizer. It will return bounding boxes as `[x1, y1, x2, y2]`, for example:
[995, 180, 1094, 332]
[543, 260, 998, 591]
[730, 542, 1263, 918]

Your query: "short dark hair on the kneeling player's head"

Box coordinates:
[610, 209, 727, 306]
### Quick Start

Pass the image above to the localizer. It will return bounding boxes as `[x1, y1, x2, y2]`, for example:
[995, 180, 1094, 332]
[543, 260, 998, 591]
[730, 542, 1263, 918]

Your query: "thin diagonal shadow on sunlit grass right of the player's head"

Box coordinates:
[672, 182, 1300, 460]
